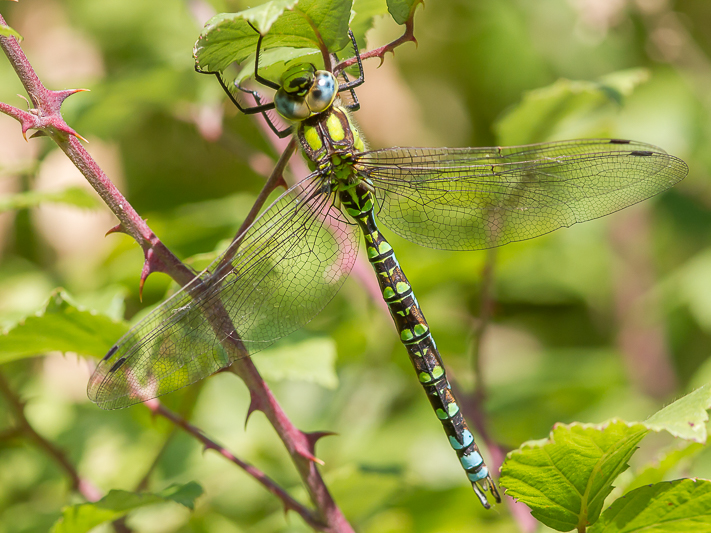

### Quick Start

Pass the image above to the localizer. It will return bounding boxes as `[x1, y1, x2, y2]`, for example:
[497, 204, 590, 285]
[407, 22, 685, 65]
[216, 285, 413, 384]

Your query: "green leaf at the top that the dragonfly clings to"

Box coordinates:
[193, 0, 352, 72]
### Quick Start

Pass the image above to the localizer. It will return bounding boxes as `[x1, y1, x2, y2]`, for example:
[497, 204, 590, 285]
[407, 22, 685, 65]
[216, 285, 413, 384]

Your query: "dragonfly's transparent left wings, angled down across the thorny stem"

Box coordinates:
[88, 177, 358, 409]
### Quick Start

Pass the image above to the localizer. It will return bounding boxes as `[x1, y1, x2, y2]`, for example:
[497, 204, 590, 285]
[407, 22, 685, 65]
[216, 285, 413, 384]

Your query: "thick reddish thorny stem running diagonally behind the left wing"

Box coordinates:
[0, 16, 352, 532]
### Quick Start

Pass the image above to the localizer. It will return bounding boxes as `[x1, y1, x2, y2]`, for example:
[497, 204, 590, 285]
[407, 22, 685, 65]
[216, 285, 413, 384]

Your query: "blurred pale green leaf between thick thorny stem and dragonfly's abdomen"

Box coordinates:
[254, 338, 338, 389]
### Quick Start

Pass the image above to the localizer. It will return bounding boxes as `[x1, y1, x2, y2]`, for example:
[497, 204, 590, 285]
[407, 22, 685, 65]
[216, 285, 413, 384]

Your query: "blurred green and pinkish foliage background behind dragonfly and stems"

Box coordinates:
[0, 0, 711, 533]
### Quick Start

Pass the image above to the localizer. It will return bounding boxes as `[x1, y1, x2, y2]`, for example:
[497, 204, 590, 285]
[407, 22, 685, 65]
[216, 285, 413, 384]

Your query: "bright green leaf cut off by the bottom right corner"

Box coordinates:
[589, 479, 711, 533]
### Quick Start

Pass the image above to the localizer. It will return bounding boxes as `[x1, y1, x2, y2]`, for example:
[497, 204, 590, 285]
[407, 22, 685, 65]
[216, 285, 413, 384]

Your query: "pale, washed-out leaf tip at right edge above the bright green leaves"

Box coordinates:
[644, 383, 711, 442]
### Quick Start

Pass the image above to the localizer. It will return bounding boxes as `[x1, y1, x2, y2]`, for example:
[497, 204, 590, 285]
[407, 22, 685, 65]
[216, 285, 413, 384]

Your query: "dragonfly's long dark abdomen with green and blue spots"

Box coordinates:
[340, 183, 499, 508]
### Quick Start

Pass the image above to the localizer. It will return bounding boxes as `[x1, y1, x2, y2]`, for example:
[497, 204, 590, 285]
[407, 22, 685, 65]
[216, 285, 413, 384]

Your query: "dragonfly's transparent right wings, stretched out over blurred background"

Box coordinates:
[356, 139, 688, 250]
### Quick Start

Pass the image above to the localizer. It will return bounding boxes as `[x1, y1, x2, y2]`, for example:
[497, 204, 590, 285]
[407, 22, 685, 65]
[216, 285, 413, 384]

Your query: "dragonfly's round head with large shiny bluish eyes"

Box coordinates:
[274, 63, 338, 121]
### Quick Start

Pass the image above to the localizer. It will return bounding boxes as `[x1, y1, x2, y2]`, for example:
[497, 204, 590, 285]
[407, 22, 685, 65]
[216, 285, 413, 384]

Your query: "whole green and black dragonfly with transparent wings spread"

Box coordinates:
[88, 28, 688, 508]
